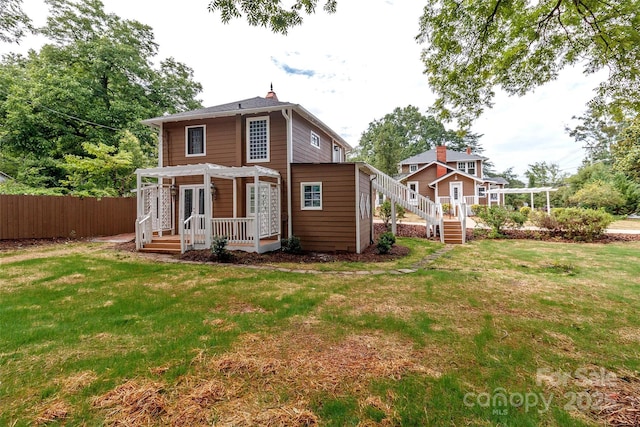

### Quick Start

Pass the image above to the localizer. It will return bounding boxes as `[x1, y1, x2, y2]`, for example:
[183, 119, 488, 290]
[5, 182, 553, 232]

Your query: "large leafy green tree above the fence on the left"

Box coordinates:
[0, 0, 202, 192]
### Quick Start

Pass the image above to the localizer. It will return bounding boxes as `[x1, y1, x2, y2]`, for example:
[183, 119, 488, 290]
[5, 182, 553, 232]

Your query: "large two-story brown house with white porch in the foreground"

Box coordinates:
[136, 90, 376, 253]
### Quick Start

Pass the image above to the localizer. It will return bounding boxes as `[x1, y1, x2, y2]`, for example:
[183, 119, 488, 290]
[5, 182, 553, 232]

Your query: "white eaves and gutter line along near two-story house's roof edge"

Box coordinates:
[140, 103, 353, 151]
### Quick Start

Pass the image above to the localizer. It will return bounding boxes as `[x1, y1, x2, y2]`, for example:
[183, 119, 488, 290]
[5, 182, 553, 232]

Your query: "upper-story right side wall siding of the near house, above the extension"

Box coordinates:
[293, 112, 333, 163]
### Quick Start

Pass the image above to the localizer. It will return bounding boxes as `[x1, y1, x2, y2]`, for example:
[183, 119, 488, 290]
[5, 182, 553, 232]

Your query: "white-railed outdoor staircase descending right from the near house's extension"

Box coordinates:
[370, 166, 466, 244]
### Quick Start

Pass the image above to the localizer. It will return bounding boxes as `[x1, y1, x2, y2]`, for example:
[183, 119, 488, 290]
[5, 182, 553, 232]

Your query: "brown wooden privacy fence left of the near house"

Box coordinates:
[0, 194, 136, 240]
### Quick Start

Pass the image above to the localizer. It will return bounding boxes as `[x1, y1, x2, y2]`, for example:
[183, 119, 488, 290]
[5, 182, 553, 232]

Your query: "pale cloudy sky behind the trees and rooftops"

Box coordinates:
[0, 0, 603, 180]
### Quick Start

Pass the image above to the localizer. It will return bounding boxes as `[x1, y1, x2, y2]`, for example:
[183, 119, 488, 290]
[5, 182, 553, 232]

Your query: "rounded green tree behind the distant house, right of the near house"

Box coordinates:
[354, 105, 482, 175]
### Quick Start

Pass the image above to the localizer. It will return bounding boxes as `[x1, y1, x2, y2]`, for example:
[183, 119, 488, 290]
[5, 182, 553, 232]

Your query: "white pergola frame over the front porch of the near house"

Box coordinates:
[136, 163, 281, 250]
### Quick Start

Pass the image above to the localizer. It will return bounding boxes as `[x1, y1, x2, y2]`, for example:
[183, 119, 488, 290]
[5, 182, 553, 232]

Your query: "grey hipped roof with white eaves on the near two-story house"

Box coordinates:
[142, 96, 353, 151]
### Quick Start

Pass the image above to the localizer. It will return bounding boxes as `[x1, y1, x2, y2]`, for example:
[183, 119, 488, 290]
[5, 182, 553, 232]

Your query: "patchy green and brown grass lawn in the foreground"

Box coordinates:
[0, 239, 640, 426]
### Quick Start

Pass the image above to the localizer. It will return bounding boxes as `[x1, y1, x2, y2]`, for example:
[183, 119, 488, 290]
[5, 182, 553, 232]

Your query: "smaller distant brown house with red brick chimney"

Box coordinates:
[396, 146, 507, 207]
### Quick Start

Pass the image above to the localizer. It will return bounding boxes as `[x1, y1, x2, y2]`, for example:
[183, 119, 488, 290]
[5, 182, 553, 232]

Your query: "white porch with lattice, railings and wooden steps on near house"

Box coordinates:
[136, 163, 282, 253]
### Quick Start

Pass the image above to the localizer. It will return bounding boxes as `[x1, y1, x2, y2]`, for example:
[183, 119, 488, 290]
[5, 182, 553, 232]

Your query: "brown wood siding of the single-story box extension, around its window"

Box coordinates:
[291, 163, 357, 252]
